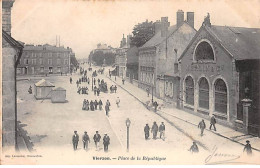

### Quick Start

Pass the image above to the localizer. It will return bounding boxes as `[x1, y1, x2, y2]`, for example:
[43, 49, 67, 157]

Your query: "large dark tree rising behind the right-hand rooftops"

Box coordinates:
[131, 20, 154, 47]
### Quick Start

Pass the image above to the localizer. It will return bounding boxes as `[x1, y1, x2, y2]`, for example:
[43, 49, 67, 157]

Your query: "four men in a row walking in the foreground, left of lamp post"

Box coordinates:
[72, 131, 110, 152]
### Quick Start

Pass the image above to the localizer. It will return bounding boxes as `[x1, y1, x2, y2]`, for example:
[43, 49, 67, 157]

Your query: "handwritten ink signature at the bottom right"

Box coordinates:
[205, 146, 240, 164]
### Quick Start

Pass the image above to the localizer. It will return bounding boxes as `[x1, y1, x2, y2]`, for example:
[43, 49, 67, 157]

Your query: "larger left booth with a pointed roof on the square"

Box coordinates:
[34, 79, 55, 100]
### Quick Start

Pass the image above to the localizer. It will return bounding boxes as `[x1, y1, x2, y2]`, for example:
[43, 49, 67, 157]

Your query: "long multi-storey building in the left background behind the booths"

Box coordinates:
[17, 44, 71, 75]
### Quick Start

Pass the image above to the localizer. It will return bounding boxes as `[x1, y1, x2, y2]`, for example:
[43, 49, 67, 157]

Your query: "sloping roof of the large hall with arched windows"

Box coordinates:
[205, 25, 260, 60]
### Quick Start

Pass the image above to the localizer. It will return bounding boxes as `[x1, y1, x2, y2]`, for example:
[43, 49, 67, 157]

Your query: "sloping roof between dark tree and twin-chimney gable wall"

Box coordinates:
[140, 25, 177, 48]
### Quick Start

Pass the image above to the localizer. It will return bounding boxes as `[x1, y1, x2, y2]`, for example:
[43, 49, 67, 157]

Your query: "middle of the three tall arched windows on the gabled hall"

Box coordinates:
[199, 77, 209, 109]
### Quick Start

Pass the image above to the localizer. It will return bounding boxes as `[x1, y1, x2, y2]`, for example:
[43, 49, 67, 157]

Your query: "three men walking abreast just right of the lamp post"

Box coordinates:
[144, 122, 165, 140]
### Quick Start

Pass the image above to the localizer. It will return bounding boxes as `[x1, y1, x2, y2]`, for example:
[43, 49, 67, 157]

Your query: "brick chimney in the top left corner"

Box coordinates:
[2, 0, 14, 35]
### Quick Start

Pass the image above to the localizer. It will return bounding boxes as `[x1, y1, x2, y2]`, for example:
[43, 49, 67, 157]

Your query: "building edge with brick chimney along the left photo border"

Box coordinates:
[2, 0, 23, 151]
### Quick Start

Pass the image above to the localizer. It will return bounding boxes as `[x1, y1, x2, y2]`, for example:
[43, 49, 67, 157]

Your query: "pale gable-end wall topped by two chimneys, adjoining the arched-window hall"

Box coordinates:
[156, 10, 196, 102]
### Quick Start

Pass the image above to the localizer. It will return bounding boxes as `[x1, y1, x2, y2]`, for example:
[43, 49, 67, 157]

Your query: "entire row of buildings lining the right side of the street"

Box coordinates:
[112, 10, 260, 136]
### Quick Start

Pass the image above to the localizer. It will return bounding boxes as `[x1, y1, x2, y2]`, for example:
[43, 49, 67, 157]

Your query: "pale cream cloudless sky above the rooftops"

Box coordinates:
[12, 0, 260, 59]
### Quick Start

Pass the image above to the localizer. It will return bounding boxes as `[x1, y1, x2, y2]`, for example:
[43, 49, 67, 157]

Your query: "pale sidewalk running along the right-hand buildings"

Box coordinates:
[108, 77, 260, 152]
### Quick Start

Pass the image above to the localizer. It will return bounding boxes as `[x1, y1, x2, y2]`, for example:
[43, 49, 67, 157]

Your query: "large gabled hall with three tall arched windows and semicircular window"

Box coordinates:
[179, 15, 260, 136]
